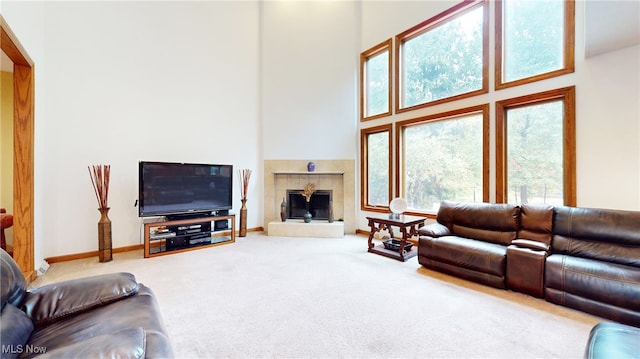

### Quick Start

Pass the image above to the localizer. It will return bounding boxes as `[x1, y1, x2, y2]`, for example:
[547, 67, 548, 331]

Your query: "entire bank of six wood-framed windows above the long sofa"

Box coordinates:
[360, 0, 576, 216]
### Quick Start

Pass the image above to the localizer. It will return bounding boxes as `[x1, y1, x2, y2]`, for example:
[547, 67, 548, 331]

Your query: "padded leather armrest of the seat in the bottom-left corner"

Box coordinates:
[22, 273, 138, 327]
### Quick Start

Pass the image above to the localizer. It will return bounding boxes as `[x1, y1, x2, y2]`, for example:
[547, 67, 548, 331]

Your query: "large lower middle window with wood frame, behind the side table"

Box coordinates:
[397, 105, 489, 212]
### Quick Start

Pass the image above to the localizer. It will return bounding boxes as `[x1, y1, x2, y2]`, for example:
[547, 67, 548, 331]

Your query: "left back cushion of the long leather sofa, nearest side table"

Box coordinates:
[437, 201, 520, 246]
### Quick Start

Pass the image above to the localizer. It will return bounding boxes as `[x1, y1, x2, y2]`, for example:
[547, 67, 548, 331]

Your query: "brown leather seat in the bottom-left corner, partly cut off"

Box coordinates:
[0, 250, 173, 359]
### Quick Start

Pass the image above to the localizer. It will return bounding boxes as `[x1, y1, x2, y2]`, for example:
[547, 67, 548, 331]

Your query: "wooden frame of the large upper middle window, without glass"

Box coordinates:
[394, 0, 489, 113]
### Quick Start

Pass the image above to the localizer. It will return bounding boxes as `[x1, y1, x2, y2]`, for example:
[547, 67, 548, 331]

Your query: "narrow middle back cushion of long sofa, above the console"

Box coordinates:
[518, 204, 553, 246]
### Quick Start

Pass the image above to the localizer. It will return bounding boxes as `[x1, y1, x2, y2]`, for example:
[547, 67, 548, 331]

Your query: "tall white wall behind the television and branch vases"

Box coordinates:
[3, 2, 262, 263]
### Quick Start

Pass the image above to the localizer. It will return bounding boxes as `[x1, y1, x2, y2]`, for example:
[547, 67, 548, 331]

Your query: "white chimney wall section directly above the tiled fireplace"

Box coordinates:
[260, 1, 360, 160]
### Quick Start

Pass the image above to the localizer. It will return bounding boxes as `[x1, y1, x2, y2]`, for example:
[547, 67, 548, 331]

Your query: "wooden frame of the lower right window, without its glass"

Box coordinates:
[496, 86, 576, 206]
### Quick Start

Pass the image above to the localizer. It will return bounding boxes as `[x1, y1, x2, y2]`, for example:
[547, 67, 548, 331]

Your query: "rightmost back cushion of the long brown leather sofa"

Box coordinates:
[552, 206, 640, 268]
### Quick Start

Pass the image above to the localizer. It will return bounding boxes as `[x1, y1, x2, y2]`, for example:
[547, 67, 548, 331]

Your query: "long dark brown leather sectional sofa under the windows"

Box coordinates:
[418, 201, 640, 327]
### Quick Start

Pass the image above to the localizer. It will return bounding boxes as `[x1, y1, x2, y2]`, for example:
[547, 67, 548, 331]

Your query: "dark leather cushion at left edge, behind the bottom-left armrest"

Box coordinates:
[0, 304, 33, 359]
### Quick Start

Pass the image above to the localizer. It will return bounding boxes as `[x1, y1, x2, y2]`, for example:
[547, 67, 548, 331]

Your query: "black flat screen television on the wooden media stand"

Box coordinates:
[138, 161, 233, 217]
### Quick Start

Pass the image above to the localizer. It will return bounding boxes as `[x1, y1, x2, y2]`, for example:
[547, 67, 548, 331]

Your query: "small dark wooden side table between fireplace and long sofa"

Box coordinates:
[367, 214, 426, 262]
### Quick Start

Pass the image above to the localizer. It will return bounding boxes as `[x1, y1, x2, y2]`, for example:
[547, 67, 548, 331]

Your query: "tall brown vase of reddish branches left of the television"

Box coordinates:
[88, 165, 112, 262]
